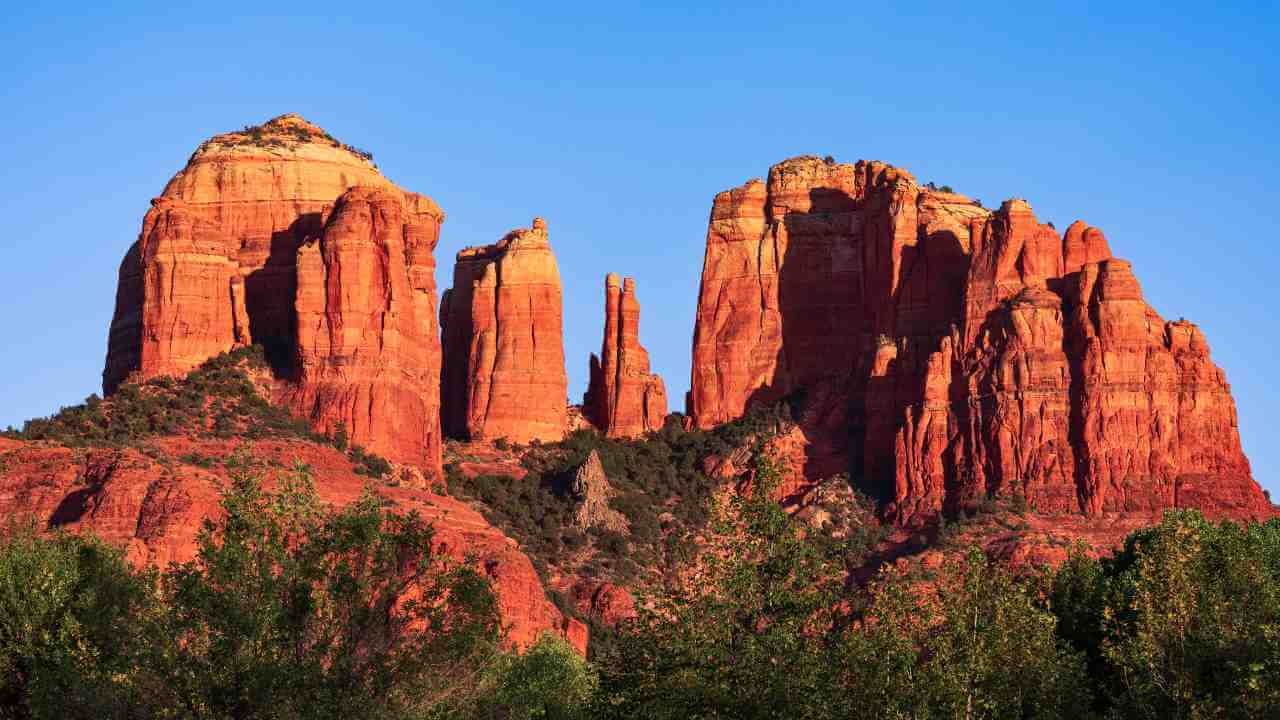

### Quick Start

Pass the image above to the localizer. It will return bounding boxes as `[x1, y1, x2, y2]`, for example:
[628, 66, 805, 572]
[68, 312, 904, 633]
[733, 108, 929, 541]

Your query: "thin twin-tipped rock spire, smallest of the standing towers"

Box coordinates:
[582, 273, 667, 437]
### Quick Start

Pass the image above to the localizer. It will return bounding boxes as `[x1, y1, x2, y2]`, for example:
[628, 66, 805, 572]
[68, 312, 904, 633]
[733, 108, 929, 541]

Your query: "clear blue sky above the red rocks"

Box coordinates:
[0, 1, 1280, 496]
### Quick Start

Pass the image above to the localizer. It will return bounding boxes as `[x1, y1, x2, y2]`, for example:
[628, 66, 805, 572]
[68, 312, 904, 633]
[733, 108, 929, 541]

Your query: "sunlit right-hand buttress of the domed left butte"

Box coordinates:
[293, 187, 440, 468]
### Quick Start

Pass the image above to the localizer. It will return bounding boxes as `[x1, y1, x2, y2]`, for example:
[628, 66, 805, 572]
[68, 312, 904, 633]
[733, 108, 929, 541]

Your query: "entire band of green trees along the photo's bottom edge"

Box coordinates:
[0, 445, 1280, 719]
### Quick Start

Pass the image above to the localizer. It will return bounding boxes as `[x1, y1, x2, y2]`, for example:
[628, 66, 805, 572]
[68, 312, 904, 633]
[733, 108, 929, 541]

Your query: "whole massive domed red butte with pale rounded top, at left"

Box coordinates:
[102, 114, 444, 474]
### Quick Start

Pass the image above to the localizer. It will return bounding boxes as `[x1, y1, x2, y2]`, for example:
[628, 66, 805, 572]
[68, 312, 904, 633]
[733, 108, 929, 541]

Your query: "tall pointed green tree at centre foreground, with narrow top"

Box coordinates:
[596, 454, 856, 719]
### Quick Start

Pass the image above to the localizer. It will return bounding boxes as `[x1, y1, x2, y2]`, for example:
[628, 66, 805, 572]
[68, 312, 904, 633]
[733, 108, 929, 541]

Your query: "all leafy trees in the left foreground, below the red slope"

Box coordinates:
[0, 458, 547, 720]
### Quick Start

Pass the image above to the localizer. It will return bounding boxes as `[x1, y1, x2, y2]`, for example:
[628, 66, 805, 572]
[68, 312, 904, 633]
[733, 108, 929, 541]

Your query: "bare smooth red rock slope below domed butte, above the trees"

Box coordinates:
[0, 436, 588, 652]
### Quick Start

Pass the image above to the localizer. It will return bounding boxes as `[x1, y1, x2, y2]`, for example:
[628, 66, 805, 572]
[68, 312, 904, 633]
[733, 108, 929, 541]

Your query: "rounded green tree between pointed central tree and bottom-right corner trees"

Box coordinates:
[846, 548, 1091, 720]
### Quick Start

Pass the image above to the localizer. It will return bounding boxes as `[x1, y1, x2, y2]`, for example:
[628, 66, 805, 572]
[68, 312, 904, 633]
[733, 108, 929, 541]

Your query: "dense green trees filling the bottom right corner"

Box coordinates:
[1046, 511, 1280, 719]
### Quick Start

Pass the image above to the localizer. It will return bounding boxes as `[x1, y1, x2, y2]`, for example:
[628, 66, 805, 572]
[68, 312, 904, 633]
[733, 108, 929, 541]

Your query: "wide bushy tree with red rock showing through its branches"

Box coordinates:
[168, 458, 499, 719]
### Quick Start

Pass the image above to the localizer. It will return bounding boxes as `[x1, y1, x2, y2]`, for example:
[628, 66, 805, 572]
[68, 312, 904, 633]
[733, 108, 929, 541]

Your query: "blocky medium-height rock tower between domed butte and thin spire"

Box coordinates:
[440, 218, 568, 443]
